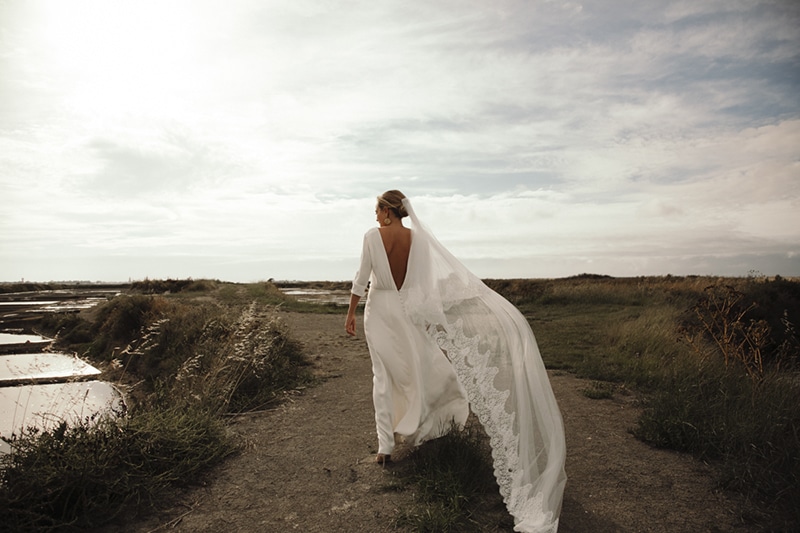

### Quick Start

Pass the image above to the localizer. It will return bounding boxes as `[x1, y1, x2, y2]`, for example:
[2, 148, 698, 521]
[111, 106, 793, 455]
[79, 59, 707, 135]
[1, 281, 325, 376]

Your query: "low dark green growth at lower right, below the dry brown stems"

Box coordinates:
[634, 359, 800, 531]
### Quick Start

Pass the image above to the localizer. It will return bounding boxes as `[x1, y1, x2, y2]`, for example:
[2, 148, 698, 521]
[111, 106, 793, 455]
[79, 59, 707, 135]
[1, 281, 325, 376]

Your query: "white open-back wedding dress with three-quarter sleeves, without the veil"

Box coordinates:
[353, 228, 469, 455]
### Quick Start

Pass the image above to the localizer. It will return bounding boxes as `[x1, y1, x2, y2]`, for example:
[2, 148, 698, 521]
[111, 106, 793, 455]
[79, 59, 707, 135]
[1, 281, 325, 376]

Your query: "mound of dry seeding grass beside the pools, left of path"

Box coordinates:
[41, 285, 309, 411]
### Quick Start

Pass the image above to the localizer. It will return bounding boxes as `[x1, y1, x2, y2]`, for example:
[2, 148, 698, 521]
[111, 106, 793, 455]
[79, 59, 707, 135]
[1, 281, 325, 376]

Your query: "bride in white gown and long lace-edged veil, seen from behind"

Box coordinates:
[345, 190, 566, 533]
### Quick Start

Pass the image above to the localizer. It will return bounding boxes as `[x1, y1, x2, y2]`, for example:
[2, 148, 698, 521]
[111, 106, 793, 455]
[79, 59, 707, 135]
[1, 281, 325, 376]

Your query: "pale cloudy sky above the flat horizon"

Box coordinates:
[0, 0, 800, 281]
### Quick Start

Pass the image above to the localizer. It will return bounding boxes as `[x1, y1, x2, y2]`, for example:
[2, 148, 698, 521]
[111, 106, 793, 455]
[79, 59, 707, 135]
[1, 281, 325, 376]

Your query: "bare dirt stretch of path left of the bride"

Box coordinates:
[107, 313, 412, 533]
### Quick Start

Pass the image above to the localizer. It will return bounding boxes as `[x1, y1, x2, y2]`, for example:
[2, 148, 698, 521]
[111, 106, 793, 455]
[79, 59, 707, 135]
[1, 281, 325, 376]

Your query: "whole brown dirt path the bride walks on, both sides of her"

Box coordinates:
[114, 313, 755, 533]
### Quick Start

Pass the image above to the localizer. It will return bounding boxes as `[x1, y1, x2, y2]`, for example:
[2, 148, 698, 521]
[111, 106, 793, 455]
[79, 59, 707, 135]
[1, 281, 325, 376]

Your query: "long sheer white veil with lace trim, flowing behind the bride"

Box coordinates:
[403, 199, 567, 533]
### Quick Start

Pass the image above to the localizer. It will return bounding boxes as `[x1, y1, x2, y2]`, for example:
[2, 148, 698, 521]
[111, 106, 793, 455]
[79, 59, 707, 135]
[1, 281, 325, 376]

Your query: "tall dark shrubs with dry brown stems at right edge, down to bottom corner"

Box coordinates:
[635, 285, 800, 529]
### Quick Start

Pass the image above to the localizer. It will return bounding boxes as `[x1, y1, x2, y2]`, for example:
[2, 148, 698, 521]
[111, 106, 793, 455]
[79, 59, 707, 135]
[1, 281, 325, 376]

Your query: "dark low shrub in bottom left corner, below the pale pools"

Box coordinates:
[0, 406, 234, 531]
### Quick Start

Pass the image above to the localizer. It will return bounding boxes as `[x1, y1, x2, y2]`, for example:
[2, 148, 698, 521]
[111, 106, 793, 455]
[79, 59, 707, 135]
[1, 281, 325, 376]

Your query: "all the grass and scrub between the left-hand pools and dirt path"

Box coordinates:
[0, 282, 311, 531]
